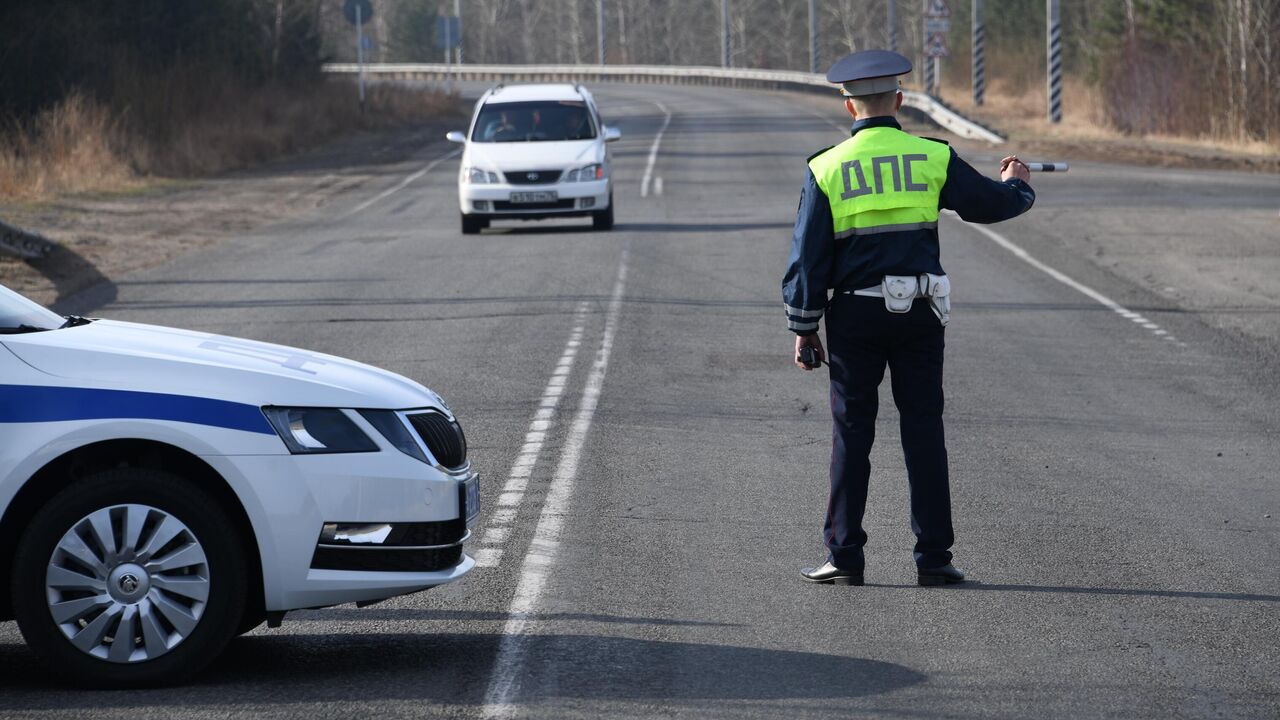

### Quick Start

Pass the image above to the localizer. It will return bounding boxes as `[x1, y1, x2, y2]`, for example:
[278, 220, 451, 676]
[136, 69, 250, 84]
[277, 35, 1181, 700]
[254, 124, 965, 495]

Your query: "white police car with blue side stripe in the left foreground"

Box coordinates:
[0, 281, 480, 687]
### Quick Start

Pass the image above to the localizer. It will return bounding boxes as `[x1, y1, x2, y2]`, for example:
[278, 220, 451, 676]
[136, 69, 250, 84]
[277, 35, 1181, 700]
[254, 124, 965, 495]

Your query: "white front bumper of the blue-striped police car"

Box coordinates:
[205, 450, 479, 611]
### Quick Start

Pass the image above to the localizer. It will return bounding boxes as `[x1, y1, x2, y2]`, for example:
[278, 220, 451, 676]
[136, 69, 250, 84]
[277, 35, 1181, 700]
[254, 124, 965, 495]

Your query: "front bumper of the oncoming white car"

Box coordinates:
[458, 179, 611, 219]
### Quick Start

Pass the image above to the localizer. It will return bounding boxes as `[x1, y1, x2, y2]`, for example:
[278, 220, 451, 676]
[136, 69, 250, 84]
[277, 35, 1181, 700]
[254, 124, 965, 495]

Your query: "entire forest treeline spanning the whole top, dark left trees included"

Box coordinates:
[0, 0, 1280, 143]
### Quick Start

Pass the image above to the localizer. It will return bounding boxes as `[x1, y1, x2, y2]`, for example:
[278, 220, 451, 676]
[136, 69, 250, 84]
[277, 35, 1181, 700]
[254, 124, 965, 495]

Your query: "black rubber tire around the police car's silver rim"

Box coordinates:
[9, 468, 248, 688]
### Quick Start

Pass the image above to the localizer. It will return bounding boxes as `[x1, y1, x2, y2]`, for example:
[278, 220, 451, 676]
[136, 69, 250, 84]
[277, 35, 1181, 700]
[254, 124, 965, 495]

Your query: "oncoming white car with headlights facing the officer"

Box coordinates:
[445, 85, 622, 234]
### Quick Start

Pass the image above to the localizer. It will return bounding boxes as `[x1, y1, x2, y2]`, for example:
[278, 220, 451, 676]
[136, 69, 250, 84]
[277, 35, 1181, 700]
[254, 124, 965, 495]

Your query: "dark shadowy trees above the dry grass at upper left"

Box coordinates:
[0, 0, 324, 115]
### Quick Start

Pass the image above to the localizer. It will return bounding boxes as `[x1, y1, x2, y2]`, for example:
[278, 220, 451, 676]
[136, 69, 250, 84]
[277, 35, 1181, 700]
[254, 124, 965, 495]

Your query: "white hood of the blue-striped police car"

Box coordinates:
[4, 320, 443, 410]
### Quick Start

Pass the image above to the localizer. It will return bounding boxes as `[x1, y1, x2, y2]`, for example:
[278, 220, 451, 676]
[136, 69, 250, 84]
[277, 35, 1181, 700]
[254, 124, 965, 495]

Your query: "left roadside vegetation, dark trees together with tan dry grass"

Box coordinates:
[0, 0, 457, 197]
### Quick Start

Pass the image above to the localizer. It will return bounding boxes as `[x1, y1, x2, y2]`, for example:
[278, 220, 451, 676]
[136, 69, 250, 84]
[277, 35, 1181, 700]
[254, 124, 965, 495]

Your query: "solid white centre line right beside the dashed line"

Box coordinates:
[483, 241, 631, 717]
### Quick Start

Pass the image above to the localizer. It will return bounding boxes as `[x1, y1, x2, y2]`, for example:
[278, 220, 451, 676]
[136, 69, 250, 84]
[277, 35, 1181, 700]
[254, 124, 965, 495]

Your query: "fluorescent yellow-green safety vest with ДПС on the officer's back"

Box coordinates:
[809, 127, 951, 240]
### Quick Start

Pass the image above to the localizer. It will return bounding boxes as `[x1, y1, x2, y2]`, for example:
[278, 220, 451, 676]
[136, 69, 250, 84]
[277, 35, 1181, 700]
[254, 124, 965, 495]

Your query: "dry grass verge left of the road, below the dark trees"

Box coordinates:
[0, 70, 458, 200]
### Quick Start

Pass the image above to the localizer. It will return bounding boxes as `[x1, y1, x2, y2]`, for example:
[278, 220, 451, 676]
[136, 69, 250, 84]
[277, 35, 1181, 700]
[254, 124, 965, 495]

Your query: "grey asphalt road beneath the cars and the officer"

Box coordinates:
[0, 86, 1280, 719]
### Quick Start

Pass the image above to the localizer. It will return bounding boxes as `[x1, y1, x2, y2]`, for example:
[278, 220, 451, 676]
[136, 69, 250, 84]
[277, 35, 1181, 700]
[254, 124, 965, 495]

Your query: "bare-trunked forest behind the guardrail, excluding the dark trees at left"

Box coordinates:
[373, 0, 1280, 143]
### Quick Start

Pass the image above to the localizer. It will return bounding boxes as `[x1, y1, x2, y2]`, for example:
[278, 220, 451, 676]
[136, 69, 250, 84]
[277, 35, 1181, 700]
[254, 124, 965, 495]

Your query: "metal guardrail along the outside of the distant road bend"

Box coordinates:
[323, 63, 1005, 145]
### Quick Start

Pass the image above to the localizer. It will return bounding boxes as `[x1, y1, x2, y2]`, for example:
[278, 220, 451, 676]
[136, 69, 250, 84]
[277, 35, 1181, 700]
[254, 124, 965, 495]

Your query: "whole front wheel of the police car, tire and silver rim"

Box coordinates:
[10, 468, 247, 688]
